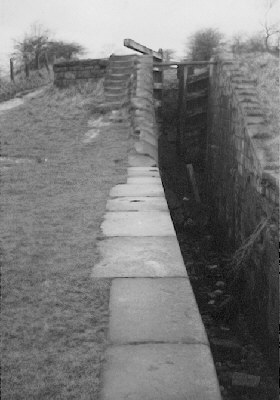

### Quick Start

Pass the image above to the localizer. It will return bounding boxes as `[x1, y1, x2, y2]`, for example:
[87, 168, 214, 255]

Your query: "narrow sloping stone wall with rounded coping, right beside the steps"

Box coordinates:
[131, 56, 158, 162]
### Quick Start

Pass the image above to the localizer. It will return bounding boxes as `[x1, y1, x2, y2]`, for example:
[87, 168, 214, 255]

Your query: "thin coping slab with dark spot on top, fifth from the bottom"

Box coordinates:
[106, 197, 168, 211]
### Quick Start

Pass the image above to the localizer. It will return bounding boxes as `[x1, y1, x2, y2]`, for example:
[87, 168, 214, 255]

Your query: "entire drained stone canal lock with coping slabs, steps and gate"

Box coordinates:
[54, 40, 278, 400]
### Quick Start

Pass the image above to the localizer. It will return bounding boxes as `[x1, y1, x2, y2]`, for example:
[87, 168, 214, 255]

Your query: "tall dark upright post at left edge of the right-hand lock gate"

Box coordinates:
[176, 65, 188, 155]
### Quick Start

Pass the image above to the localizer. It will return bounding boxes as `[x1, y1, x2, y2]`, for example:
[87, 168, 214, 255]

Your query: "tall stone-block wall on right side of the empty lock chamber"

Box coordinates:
[206, 49, 279, 368]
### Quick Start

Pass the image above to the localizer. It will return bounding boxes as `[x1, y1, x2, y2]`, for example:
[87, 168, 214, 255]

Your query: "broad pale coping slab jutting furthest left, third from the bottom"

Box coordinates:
[92, 236, 187, 278]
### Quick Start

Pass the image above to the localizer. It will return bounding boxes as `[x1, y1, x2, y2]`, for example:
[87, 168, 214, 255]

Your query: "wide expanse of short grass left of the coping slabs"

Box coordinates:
[0, 79, 127, 400]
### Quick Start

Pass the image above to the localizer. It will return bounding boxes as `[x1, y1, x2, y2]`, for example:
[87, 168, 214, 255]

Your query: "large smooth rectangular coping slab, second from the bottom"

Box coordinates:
[109, 278, 208, 344]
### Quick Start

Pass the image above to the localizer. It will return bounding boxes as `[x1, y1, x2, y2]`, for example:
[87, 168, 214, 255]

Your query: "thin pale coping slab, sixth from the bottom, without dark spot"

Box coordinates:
[110, 183, 164, 197]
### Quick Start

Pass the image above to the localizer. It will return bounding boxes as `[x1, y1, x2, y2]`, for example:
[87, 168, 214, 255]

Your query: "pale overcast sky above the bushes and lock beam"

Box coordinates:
[0, 0, 280, 69]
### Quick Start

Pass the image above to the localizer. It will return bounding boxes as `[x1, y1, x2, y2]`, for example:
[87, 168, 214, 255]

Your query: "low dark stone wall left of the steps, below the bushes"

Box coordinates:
[53, 59, 109, 88]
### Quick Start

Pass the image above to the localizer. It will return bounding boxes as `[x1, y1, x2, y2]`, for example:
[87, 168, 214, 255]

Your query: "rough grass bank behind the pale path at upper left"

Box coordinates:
[0, 70, 52, 102]
